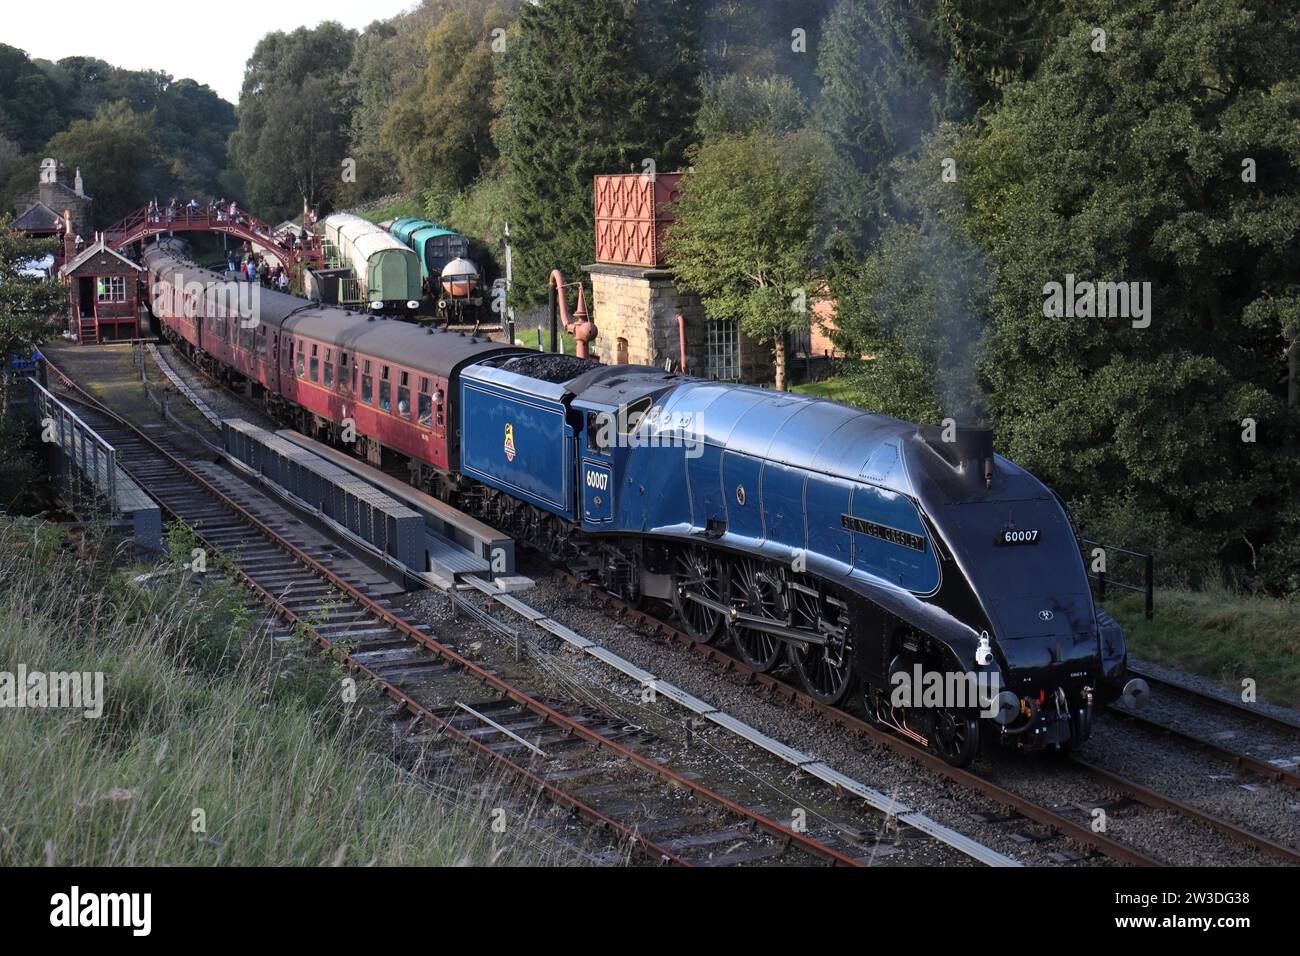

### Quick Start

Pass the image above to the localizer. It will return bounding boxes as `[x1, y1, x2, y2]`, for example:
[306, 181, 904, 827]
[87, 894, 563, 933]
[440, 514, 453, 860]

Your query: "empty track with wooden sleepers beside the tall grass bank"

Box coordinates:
[49, 363, 982, 866]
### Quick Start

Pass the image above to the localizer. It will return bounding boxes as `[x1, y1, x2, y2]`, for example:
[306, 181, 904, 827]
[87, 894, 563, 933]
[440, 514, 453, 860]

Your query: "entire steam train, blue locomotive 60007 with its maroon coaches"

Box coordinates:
[144, 241, 1144, 765]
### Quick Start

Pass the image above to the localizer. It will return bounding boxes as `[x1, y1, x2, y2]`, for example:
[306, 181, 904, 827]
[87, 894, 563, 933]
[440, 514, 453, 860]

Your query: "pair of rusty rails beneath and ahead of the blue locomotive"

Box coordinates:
[558, 571, 1300, 865]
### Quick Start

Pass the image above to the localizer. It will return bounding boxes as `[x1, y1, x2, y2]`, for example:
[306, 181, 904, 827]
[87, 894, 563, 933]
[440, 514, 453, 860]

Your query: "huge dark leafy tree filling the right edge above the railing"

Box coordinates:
[972, 0, 1300, 589]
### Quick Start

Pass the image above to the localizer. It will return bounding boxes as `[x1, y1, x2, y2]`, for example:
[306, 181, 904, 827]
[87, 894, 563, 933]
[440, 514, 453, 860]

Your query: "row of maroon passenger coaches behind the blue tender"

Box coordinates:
[135, 241, 512, 484]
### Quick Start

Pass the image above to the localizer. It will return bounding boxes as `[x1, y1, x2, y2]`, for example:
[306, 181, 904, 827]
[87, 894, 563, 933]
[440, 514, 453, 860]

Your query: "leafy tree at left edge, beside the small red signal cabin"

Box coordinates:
[0, 220, 68, 419]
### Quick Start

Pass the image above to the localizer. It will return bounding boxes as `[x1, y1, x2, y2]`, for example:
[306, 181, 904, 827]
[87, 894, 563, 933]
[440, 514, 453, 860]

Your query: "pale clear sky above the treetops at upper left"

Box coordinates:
[0, 0, 417, 103]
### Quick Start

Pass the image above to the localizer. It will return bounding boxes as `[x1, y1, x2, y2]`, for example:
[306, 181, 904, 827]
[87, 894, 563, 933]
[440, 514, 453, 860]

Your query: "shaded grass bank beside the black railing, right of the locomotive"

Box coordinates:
[1105, 588, 1300, 708]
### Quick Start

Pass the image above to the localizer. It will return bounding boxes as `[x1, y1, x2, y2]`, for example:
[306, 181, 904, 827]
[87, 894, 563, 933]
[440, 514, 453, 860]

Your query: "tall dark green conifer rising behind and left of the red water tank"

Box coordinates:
[495, 0, 699, 307]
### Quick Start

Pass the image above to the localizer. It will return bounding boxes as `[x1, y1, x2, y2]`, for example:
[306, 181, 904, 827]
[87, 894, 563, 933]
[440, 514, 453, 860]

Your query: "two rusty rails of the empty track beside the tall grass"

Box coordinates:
[44, 358, 861, 866]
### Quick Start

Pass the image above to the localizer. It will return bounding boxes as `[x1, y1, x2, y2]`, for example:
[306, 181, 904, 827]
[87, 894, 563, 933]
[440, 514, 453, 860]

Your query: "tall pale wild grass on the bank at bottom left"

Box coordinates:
[0, 522, 579, 866]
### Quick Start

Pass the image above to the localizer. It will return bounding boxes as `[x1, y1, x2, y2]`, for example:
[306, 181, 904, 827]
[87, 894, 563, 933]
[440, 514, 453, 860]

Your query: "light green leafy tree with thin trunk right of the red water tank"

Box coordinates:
[667, 133, 823, 389]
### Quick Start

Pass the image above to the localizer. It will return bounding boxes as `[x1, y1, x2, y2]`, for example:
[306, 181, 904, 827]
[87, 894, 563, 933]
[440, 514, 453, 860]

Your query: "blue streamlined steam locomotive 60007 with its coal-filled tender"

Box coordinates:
[459, 354, 1144, 765]
